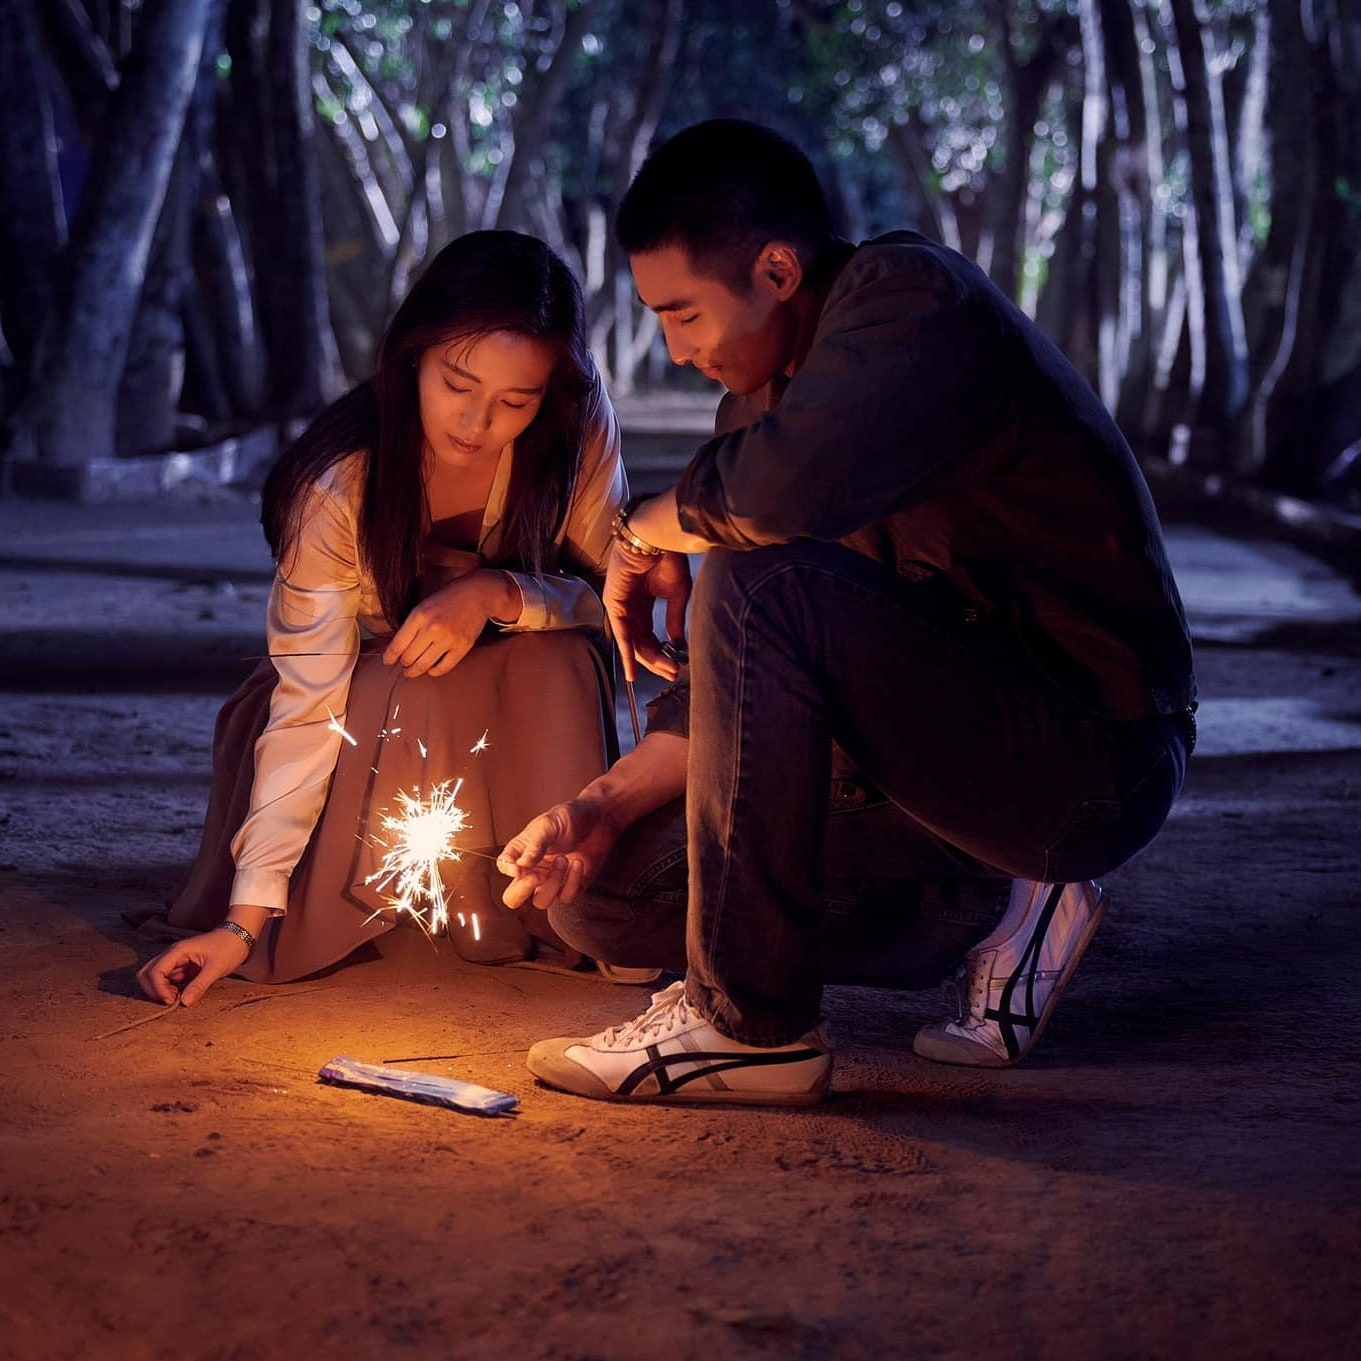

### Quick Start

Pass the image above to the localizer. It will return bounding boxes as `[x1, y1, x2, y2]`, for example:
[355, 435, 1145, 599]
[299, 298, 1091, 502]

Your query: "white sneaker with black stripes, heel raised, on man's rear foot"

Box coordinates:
[912, 879, 1105, 1068]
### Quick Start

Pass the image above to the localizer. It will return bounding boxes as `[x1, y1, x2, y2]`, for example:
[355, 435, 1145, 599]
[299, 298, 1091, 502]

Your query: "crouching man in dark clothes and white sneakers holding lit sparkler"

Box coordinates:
[502, 120, 1195, 1104]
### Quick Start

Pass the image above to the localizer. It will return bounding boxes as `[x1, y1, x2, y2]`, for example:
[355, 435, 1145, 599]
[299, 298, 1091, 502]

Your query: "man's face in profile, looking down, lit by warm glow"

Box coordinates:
[629, 246, 798, 396]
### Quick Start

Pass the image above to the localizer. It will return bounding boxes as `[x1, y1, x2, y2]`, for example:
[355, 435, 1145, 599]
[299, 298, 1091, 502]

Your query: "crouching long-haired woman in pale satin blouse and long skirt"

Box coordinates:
[137, 231, 627, 1004]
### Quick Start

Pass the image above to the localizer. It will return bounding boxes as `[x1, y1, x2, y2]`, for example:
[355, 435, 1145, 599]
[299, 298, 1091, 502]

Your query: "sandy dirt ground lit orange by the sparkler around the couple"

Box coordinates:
[0, 494, 1361, 1361]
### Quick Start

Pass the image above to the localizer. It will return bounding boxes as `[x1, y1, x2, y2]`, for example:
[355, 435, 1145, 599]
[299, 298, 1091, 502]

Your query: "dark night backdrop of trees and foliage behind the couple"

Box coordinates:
[0, 0, 1361, 508]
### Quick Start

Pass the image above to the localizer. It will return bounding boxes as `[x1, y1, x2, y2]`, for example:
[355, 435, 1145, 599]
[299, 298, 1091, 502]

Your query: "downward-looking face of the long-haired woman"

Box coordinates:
[416, 331, 557, 468]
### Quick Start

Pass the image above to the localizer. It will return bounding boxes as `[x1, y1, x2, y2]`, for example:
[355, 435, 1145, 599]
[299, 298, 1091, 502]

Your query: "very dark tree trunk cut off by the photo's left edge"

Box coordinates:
[0, 0, 67, 397]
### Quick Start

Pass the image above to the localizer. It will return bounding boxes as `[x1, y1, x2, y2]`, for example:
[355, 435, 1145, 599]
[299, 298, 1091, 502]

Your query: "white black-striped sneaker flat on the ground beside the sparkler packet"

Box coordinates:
[527, 980, 832, 1105]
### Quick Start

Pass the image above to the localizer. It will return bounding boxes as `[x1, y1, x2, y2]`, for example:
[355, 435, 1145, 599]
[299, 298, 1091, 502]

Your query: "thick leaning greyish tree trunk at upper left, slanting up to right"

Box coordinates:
[16, 0, 208, 464]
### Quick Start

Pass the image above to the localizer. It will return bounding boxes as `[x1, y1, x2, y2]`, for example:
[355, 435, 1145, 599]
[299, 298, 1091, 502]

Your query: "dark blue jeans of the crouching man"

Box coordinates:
[553, 542, 1187, 1045]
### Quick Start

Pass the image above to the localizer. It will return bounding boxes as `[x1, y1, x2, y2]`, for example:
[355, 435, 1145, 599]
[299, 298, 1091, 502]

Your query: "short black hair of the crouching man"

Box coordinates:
[614, 118, 833, 293]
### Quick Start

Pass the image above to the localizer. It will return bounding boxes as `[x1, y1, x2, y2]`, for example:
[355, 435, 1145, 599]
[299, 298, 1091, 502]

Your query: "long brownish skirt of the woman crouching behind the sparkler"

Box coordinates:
[136, 630, 614, 983]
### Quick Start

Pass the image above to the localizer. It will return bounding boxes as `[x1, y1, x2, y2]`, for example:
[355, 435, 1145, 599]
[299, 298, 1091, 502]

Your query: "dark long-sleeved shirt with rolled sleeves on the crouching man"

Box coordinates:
[678, 231, 1195, 719]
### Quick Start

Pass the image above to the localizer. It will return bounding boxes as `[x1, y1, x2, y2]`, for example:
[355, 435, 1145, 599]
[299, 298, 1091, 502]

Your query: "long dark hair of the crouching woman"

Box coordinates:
[260, 231, 595, 623]
